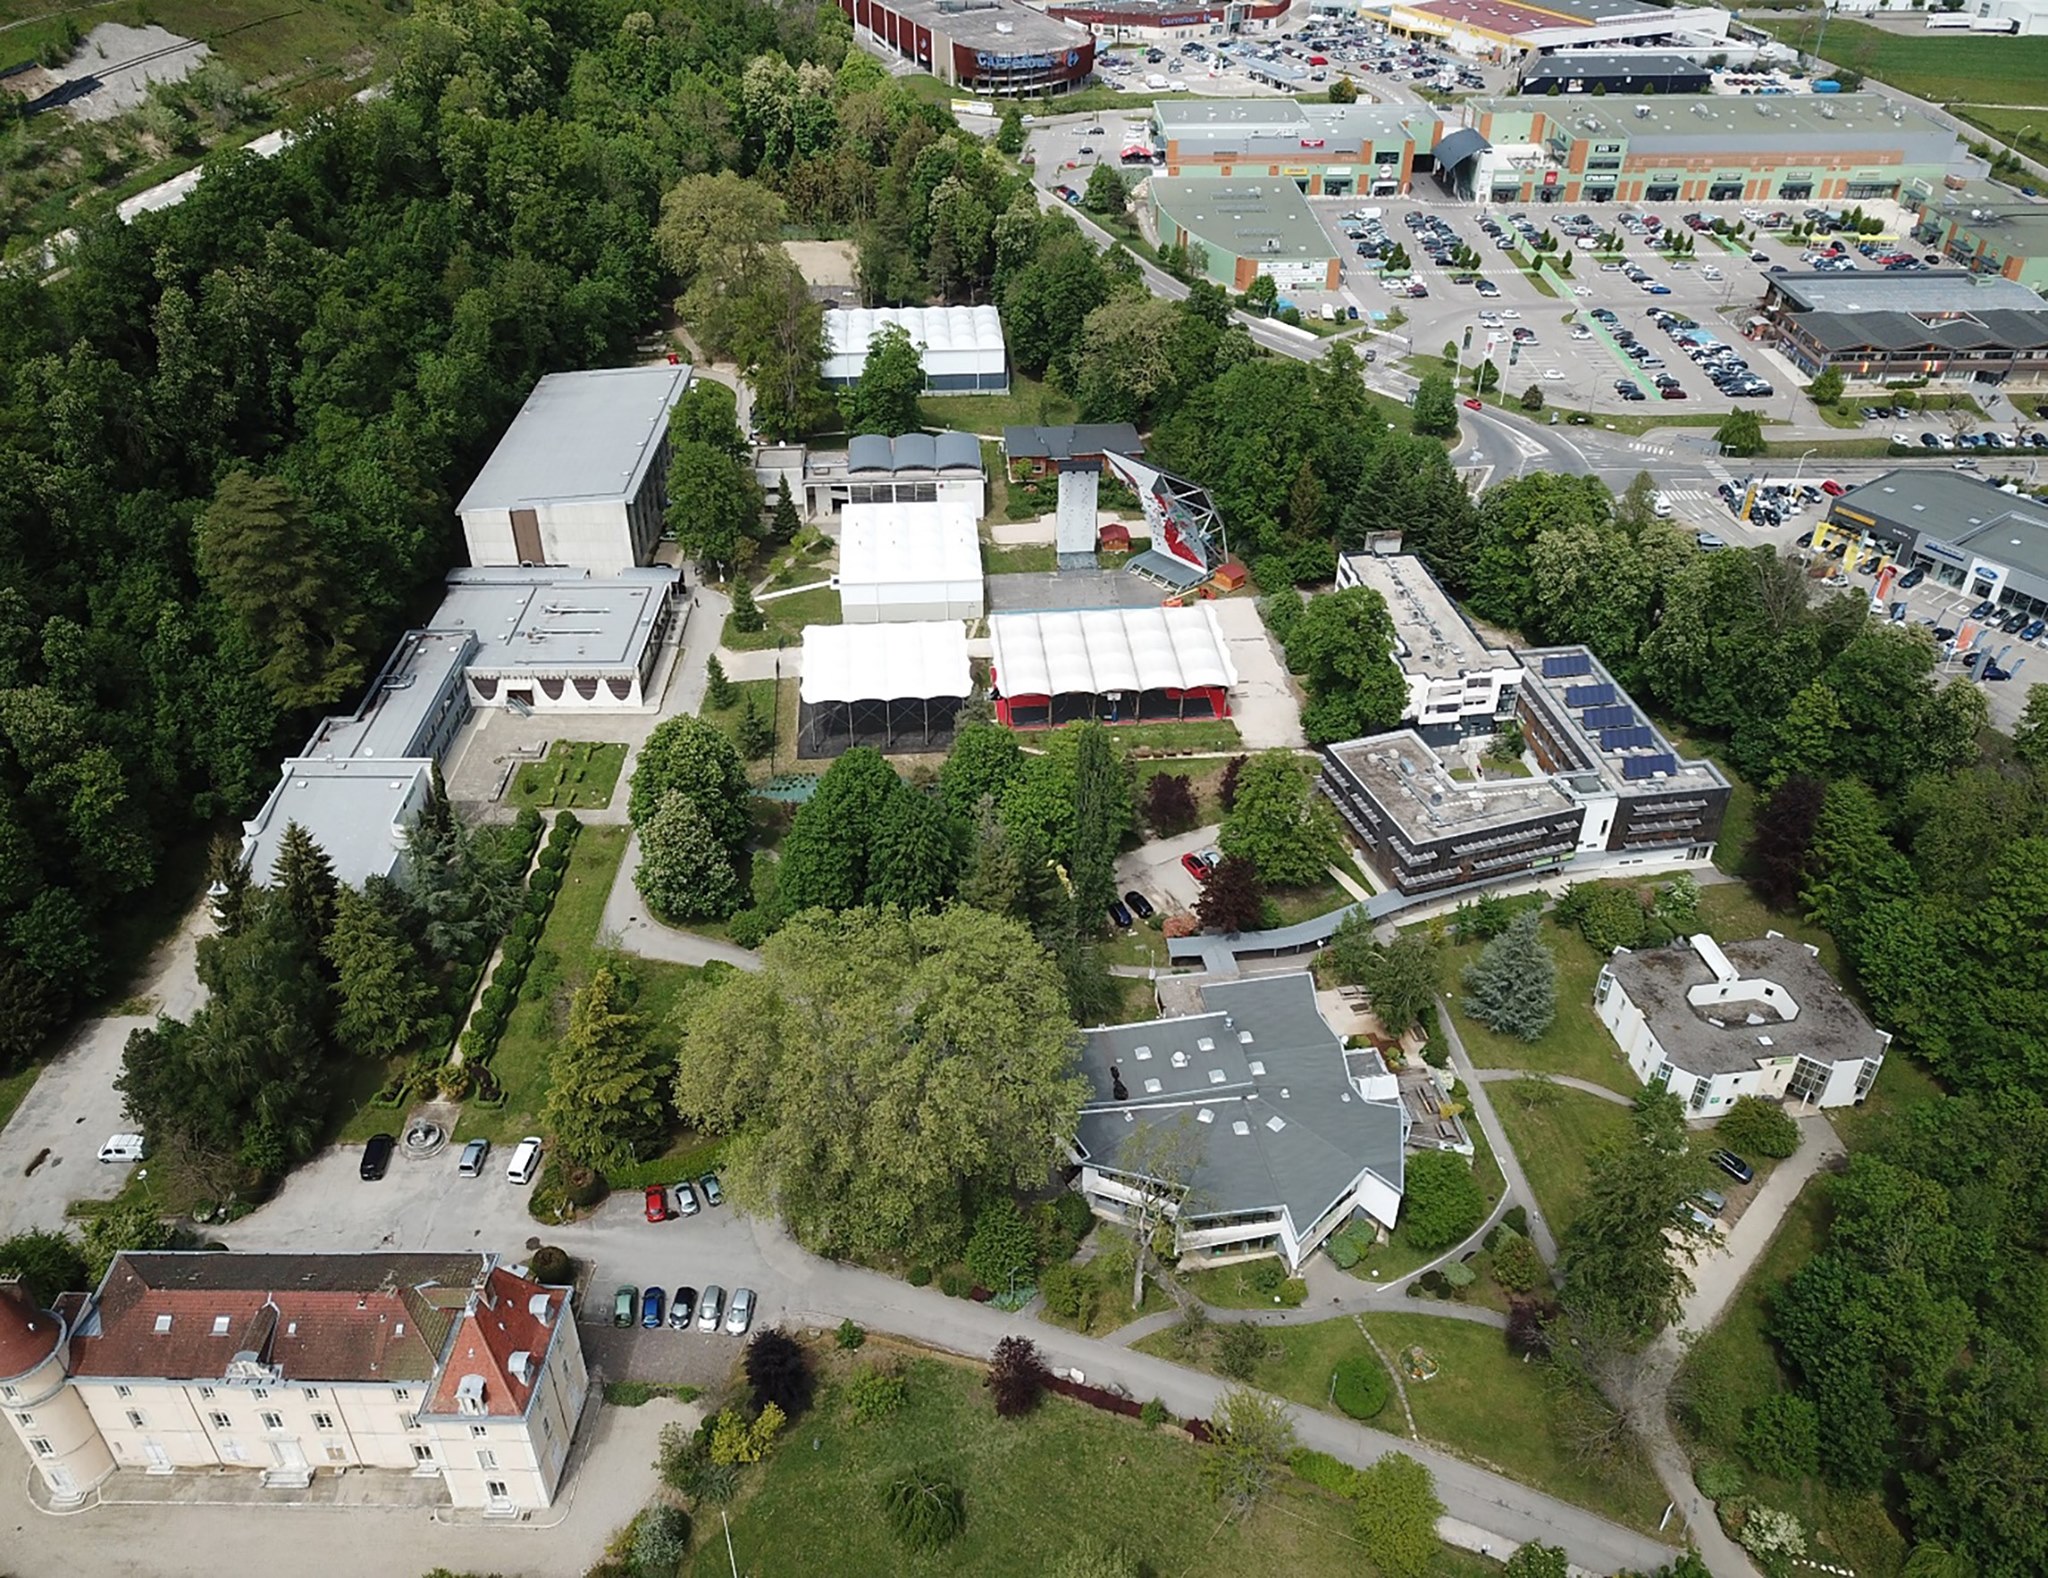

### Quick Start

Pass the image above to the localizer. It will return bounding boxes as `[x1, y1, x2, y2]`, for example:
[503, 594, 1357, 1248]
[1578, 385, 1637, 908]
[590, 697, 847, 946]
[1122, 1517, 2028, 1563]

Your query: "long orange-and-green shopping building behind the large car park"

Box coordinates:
[1448, 94, 1960, 205]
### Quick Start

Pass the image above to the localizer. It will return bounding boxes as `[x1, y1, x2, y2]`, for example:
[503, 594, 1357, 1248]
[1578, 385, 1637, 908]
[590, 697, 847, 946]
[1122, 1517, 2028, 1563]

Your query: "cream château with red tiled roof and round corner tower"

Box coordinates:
[0, 1251, 590, 1517]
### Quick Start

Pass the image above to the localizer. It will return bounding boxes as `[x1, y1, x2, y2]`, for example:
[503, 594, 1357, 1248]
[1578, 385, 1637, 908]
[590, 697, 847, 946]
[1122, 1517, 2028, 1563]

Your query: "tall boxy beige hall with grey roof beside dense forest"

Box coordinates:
[457, 362, 690, 575]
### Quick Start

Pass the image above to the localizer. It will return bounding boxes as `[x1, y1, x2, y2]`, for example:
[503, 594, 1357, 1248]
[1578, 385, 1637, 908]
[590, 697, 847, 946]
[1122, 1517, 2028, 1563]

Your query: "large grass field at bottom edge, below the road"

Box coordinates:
[684, 1343, 1499, 1578]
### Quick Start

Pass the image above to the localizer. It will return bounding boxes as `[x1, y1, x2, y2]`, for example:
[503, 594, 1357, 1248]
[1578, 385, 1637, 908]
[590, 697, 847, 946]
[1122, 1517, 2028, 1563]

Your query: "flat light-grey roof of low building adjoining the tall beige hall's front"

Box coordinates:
[434, 565, 678, 671]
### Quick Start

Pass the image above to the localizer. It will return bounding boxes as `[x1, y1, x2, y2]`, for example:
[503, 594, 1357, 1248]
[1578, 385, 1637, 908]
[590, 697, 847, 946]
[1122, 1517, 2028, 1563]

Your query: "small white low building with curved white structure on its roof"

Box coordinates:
[1593, 931, 1892, 1117]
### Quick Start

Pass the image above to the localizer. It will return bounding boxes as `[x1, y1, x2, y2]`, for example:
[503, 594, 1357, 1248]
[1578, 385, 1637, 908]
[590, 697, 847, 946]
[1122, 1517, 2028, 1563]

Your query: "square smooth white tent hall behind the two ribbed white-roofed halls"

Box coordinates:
[834, 499, 985, 624]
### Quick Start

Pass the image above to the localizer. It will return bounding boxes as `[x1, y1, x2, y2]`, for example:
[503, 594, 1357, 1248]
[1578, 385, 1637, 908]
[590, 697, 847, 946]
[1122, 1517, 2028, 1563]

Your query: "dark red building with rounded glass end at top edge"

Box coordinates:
[840, 0, 1096, 98]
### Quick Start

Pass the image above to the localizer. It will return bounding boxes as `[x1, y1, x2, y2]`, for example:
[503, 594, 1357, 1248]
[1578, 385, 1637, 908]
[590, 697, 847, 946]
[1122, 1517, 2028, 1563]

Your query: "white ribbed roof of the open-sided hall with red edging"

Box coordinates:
[989, 604, 1237, 696]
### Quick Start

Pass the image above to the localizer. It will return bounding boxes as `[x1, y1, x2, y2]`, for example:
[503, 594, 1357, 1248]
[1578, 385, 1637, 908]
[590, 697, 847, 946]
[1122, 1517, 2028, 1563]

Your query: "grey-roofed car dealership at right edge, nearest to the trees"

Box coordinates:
[1815, 467, 2048, 614]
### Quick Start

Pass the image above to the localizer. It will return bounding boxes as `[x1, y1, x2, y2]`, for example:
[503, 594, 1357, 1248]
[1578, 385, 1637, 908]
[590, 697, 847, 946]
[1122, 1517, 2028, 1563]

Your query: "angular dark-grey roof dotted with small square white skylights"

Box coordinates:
[1077, 974, 1407, 1232]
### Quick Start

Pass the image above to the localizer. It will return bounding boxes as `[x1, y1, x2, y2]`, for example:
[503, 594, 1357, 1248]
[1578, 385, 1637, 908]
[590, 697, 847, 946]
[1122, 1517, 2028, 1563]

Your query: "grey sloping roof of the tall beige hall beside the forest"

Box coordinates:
[457, 362, 690, 514]
